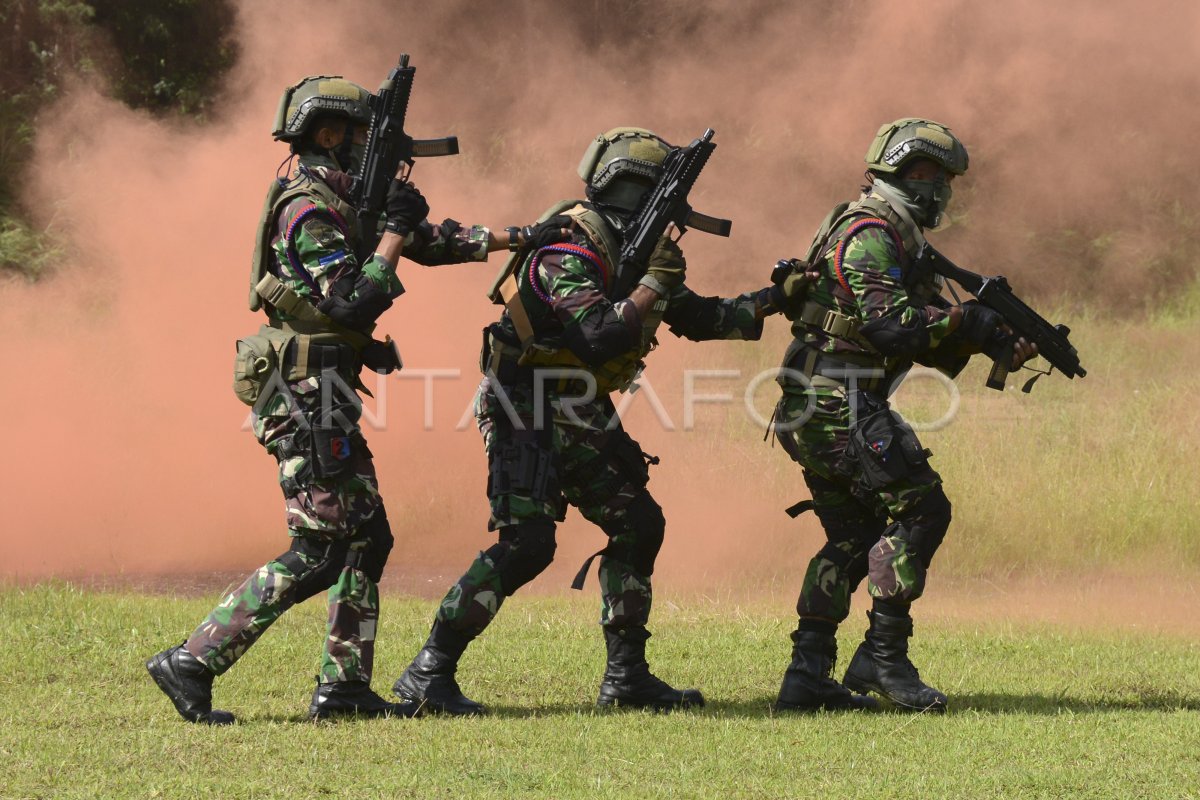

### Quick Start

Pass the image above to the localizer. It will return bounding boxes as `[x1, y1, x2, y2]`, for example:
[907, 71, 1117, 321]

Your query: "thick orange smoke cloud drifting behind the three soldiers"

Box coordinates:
[0, 0, 1200, 585]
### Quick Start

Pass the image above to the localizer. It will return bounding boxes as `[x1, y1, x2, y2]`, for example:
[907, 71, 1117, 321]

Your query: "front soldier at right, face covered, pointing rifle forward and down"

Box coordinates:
[775, 119, 1037, 712]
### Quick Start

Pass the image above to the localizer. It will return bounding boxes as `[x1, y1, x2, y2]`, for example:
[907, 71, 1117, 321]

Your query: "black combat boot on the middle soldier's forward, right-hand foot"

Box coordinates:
[596, 626, 704, 711]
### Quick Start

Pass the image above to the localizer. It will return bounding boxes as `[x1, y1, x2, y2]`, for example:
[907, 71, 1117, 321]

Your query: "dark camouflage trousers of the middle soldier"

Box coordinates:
[437, 378, 665, 636]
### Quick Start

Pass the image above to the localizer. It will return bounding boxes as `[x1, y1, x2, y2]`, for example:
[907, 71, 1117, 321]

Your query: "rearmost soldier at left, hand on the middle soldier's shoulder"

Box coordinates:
[146, 77, 520, 724]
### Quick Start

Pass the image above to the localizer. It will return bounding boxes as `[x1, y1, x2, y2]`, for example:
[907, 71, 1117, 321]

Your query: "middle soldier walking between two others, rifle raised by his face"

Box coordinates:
[394, 127, 774, 715]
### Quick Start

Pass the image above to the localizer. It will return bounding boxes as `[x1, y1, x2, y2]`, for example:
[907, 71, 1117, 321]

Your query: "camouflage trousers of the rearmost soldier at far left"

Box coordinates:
[186, 378, 391, 682]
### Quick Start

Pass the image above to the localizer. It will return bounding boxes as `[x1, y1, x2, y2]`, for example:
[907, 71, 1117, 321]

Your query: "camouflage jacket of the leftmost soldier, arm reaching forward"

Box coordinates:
[269, 156, 490, 320]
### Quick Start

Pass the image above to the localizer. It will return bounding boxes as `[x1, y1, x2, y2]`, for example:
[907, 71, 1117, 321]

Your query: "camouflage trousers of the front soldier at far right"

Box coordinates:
[775, 384, 949, 624]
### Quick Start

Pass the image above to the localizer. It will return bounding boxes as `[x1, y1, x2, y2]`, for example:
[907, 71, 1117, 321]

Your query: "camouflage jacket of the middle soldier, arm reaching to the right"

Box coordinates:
[498, 224, 773, 367]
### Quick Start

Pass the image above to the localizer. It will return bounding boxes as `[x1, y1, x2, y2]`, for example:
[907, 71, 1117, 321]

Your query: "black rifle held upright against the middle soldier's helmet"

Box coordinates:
[619, 128, 733, 292]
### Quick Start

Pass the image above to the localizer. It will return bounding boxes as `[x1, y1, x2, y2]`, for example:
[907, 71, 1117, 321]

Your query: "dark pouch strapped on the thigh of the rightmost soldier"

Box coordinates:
[846, 403, 932, 489]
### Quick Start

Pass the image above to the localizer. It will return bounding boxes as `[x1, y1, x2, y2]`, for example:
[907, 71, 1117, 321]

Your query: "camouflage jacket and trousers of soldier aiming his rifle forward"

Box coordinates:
[775, 179, 965, 624]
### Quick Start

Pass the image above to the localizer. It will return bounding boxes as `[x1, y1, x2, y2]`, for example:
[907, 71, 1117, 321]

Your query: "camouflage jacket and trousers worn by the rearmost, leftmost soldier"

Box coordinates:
[186, 155, 488, 684]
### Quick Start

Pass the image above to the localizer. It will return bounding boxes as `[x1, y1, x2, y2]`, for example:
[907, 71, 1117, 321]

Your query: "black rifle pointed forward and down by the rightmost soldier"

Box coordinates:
[919, 242, 1087, 392]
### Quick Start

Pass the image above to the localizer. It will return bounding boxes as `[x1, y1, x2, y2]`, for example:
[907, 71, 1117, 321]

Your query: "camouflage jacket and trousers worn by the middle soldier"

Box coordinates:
[438, 226, 767, 636]
